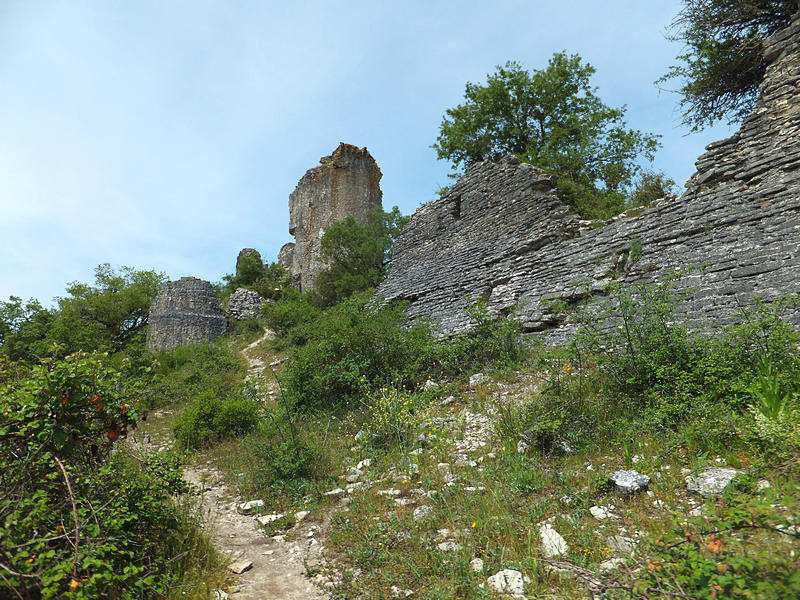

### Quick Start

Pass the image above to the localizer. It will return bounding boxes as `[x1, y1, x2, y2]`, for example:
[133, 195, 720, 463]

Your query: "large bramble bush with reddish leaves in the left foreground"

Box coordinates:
[0, 354, 222, 600]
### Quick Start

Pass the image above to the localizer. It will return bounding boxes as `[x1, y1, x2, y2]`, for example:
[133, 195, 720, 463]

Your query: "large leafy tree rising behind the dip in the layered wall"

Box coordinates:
[433, 53, 659, 217]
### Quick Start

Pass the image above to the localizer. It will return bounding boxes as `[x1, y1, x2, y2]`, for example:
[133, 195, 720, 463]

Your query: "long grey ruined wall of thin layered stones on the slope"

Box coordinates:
[377, 15, 800, 342]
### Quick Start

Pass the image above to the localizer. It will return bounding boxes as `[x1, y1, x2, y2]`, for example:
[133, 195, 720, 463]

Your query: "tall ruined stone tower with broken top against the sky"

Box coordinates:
[278, 142, 382, 292]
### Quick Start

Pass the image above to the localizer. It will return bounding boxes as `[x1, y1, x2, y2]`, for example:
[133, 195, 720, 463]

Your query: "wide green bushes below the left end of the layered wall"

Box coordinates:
[276, 292, 528, 407]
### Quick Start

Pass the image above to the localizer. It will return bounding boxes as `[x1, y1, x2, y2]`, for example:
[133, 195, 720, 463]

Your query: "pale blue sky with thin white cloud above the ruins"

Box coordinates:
[0, 0, 730, 304]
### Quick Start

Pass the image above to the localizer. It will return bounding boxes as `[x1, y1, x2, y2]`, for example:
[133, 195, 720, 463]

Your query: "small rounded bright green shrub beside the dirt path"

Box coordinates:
[173, 391, 258, 448]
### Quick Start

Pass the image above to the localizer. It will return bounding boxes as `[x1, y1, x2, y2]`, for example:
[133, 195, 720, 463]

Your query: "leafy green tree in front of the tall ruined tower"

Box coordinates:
[314, 206, 409, 307]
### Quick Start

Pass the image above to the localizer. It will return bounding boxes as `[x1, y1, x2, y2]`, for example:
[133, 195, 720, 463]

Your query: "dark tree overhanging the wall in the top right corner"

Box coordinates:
[656, 0, 798, 131]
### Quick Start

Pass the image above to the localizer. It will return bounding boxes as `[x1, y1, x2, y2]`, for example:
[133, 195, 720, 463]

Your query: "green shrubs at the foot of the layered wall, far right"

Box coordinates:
[576, 284, 800, 426]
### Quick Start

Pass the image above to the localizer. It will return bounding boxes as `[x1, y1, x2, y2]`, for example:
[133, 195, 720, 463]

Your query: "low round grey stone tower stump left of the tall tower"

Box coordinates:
[147, 277, 228, 351]
